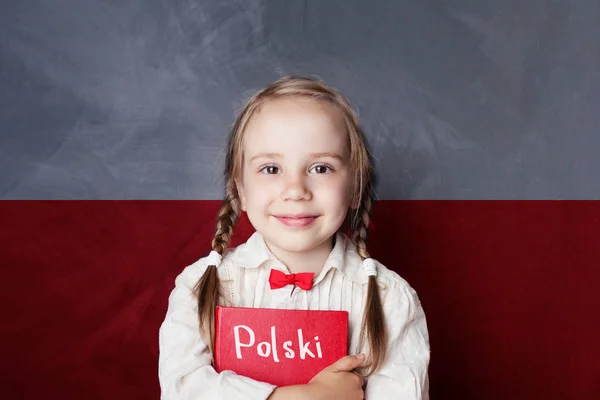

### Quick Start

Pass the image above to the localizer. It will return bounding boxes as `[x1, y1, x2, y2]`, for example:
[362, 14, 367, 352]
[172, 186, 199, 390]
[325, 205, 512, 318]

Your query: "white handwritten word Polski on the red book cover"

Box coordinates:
[233, 325, 323, 362]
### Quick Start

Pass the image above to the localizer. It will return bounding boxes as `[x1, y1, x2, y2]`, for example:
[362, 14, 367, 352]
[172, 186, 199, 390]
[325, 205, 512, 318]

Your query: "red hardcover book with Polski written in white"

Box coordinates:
[215, 307, 348, 386]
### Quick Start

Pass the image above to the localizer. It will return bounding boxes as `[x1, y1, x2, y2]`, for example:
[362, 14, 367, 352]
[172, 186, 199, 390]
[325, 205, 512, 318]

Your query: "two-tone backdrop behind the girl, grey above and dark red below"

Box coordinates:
[0, 0, 600, 399]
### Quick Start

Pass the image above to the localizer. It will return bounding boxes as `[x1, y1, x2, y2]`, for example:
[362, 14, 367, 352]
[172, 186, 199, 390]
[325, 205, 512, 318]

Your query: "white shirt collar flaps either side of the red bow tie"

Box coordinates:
[234, 228, 369, 284]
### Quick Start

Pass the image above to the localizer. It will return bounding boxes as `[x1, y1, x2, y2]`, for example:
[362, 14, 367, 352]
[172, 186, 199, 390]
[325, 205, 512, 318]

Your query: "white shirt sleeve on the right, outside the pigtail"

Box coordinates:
[365, 286, 430, 400]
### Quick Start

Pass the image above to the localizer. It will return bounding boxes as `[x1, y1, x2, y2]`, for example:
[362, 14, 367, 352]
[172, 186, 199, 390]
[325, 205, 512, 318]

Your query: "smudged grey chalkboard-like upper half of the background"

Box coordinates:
[0, 0, 600, 199]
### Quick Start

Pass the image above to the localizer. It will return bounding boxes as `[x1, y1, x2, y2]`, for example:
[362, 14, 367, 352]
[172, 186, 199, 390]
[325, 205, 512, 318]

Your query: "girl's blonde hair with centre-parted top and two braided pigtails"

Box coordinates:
[195, 76, 388, 375]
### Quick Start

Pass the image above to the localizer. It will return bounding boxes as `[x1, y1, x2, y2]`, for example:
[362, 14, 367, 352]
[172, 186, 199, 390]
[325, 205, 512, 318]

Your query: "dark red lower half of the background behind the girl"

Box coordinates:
[0, 201, 600, 399]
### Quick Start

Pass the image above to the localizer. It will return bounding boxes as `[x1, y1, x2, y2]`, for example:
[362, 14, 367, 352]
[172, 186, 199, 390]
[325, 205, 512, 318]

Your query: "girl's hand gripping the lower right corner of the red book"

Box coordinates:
[307, 354, 365, 400]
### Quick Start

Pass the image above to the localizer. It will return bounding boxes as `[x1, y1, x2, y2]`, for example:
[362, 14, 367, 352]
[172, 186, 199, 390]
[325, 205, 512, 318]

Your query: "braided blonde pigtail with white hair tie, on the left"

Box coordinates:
[195, 179, 241, 357]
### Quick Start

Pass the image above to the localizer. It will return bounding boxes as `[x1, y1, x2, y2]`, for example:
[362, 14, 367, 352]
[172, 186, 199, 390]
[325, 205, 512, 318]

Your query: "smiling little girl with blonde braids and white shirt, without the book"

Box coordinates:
[159, 77, 429, 400]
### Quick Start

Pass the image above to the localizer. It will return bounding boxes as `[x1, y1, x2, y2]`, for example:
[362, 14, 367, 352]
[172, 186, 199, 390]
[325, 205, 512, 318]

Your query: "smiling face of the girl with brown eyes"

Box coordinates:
[236, 98, 353, 253]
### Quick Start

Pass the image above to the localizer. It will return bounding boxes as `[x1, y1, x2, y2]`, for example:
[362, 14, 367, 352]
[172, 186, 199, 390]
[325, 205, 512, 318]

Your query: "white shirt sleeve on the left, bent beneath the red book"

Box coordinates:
[158, 260, 275, 400]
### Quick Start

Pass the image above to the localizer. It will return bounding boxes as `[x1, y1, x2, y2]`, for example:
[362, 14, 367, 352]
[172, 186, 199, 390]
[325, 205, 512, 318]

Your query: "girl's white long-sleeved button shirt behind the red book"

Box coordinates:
[159, 232, 429, 400]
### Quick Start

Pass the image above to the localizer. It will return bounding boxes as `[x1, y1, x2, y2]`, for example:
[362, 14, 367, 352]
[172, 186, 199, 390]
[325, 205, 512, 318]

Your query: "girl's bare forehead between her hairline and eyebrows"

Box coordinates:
[243, 97, 349, 157]
